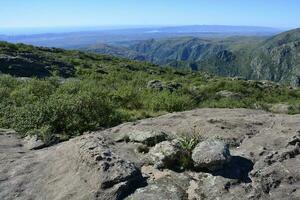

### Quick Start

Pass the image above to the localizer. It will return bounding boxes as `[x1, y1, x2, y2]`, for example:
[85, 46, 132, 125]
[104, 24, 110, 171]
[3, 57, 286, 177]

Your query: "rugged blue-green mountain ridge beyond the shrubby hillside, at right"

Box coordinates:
[85, 29, 300, 86]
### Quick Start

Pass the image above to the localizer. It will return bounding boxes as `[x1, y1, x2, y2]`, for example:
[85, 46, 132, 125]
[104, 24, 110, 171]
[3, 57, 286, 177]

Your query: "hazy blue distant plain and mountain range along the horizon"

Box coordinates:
[0, 25, 282, 48]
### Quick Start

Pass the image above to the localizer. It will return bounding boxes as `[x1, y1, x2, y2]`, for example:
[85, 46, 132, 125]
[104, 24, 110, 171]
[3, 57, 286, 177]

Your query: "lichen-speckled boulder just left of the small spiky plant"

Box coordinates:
[149, 140, 182, 169]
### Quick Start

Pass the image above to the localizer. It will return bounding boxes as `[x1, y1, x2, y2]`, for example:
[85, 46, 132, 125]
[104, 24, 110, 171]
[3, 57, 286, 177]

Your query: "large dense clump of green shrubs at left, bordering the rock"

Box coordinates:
[0, 77, 122, 140]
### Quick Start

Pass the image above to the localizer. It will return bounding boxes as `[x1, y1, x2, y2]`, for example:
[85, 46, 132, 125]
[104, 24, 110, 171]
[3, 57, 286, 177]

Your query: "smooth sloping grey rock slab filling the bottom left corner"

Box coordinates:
[0, 135, 143, 200]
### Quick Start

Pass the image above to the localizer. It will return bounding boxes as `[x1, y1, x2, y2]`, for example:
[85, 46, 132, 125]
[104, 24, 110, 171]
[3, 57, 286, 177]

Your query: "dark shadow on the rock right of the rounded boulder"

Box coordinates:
[212, 156, 254, 183]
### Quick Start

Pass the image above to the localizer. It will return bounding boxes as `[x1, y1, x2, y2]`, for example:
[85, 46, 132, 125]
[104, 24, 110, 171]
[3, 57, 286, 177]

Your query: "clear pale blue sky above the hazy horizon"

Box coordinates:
[0, 0, 300, 28]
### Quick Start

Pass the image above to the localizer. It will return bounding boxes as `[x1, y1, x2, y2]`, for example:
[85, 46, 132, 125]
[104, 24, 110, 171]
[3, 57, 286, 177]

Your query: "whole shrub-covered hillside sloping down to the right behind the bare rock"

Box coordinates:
[0, 43, 300, 143]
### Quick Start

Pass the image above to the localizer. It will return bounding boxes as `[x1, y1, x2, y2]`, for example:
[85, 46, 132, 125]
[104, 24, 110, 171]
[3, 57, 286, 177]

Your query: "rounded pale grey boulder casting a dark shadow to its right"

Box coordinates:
[192, 140, 231, 171]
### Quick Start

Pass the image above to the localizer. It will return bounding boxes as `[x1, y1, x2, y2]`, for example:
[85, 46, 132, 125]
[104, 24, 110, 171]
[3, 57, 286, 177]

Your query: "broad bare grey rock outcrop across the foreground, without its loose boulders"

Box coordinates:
[0, 109, 300, 200]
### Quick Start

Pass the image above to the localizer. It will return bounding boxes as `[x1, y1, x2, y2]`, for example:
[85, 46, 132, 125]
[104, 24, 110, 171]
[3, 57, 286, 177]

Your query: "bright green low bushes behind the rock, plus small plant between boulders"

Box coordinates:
[0, 72, 300, 142]
